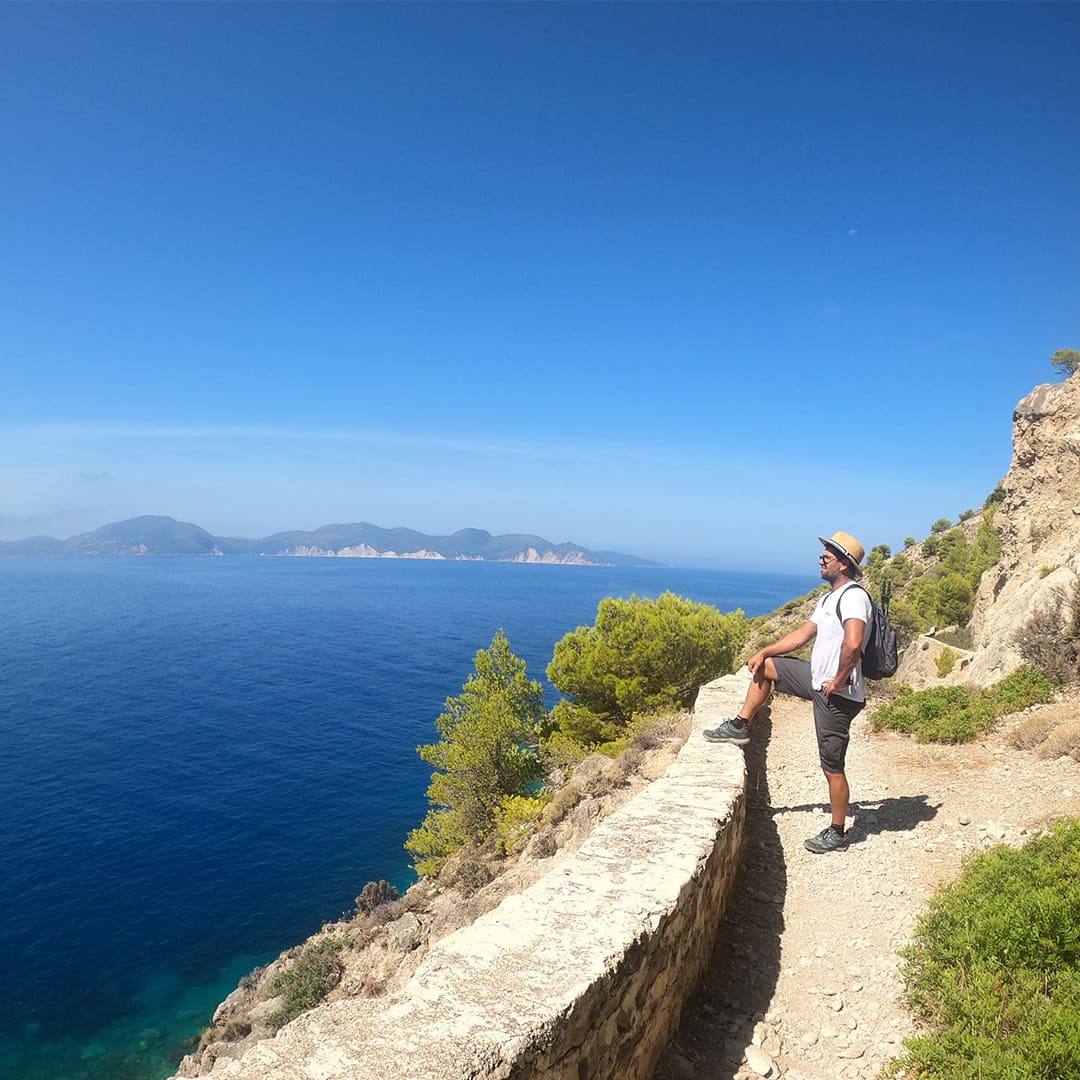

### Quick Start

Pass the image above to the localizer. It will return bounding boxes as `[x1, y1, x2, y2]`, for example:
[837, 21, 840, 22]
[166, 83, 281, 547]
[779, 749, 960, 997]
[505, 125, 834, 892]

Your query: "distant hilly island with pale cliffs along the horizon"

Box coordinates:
[0, 515, 663, 566]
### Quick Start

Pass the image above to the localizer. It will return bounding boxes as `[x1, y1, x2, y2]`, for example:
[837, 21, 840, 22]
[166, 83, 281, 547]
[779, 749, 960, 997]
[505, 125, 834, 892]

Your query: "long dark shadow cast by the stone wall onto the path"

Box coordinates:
[652, 708, 787, 1080]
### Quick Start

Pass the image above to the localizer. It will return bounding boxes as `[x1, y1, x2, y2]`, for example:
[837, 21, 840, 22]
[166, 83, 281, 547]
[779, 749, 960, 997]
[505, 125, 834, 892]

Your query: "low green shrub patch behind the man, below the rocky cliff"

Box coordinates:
[870, 665, 1059, 743]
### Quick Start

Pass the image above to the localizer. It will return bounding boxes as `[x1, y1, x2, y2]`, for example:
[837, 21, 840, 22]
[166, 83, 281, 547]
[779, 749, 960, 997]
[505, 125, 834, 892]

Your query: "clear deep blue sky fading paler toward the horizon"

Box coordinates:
[0, 3, 1080, 570]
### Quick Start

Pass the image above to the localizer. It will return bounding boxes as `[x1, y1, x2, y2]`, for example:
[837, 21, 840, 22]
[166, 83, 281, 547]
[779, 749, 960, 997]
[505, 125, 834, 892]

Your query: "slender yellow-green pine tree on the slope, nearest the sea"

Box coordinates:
[405, 630, 546, 876]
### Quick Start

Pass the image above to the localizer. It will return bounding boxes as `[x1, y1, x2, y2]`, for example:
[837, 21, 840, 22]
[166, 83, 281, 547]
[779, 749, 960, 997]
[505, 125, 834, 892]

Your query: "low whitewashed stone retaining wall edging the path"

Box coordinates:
[190, 676, 746, 1080]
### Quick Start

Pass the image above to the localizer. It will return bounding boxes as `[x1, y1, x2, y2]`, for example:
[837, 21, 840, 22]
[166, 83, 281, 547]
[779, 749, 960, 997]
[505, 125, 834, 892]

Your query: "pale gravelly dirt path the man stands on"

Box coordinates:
[654, 698, 1080, 1080]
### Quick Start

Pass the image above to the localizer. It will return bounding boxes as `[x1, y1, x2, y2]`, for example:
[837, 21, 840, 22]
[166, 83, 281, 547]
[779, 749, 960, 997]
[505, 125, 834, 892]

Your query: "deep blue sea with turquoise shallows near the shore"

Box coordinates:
[0, 557, 816, 1080]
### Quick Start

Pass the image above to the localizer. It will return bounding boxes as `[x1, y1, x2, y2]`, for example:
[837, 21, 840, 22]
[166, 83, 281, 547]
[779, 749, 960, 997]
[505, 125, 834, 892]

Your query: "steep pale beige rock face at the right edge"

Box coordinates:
[964, 375, 1080, 686]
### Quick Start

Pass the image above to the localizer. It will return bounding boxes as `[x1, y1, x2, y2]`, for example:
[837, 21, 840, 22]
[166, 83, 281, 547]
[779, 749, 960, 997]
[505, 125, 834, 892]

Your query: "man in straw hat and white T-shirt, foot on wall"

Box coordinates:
[704, 532, 874, 854]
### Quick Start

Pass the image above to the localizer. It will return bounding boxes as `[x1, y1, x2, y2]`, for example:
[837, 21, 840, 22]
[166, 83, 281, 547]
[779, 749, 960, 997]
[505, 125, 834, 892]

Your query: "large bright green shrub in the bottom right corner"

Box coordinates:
[890, 819, 1080, 1080]
